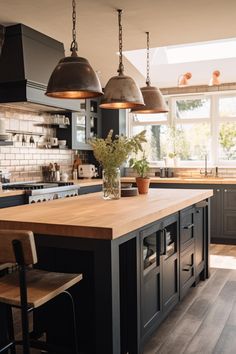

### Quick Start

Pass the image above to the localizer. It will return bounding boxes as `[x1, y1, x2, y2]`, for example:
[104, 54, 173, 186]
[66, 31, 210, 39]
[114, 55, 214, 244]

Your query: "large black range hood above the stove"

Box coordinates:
[0, 24, 80, 112]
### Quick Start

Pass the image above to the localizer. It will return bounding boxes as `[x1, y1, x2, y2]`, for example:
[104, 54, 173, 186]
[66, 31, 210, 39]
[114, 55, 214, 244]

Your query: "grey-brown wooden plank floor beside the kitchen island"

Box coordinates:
[144, 245, 236, 354]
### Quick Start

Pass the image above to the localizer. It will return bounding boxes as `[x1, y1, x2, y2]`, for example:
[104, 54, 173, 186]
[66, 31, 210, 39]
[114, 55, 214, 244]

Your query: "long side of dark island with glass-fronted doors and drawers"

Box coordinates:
[140, 201, 208, 348]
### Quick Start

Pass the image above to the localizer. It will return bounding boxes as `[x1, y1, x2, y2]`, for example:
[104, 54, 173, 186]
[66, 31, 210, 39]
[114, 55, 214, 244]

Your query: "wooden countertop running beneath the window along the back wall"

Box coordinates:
[121, 177, 236, 188]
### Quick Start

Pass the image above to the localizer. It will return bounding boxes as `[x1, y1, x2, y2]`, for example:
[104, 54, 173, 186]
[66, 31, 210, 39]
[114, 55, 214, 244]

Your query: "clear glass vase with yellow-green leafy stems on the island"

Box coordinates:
[89, 130, 146, 199]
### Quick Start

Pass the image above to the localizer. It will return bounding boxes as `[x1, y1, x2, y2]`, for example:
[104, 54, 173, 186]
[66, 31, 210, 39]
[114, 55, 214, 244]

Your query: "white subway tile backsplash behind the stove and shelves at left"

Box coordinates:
[0, 107, 74, 181]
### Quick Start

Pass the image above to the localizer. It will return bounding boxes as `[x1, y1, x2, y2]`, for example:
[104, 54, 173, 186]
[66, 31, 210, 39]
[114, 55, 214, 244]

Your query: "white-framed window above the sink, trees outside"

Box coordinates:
[130, 93, 236, 166]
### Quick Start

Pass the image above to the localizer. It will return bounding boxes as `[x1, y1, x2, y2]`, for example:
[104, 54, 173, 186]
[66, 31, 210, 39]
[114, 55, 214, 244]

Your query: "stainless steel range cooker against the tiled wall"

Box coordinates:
[2, 182, 80, 204]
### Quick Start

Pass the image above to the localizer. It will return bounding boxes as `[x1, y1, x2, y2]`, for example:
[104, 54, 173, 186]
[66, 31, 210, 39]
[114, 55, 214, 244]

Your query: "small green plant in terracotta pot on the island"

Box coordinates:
[129, 154, 150, 194]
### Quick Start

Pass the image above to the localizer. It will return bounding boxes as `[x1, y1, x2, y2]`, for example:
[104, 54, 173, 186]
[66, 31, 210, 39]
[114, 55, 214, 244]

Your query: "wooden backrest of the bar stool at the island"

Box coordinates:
[0, 230, 38, 265]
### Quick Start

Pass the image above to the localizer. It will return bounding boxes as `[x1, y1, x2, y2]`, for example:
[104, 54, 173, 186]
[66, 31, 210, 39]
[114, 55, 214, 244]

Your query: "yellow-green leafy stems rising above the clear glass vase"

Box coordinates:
[89, 130, 146, 170]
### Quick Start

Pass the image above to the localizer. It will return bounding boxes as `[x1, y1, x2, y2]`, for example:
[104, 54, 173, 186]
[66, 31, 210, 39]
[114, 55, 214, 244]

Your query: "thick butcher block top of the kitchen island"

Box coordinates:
[0, 189, 213, 240]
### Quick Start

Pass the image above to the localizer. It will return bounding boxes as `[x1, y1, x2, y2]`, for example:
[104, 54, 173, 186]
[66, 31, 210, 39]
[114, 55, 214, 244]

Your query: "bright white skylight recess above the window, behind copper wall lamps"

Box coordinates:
[123, 38, 236, 88]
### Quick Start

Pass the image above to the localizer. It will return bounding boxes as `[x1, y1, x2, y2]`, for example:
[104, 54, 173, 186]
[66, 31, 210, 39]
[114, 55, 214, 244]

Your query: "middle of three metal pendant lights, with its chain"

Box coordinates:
[100, 10, 144, 109]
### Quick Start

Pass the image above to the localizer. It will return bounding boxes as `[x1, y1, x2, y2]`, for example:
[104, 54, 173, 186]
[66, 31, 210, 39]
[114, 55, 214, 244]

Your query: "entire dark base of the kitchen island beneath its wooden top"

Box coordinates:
[18, 196, 209, 354]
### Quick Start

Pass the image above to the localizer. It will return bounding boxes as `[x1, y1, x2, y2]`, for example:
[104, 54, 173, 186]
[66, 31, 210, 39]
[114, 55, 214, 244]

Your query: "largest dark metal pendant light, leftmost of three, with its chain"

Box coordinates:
[46, 0, 103, 99]
